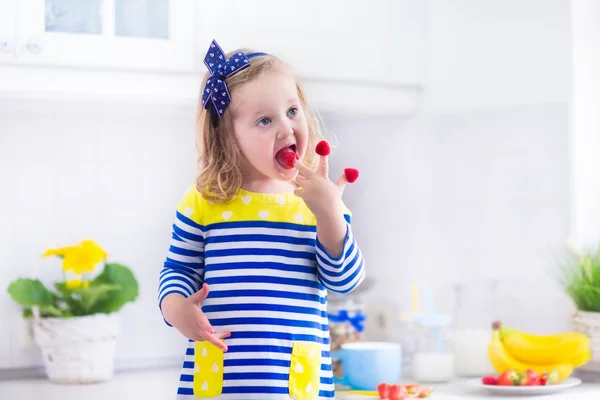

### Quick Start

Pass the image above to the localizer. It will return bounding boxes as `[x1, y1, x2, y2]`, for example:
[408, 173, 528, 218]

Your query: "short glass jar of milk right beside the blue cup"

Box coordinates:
[411, 314, 455, 382]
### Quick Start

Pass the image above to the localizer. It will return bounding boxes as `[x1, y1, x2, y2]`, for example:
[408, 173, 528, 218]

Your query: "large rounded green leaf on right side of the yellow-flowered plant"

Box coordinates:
[90, 263, 139, 313]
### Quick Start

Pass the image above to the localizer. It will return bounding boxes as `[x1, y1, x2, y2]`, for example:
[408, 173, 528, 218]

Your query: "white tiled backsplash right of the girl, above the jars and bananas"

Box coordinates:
[329, 103, 570, 332]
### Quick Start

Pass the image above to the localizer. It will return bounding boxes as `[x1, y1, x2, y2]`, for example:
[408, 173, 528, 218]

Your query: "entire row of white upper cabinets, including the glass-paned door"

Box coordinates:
[0, 0, 426, 114]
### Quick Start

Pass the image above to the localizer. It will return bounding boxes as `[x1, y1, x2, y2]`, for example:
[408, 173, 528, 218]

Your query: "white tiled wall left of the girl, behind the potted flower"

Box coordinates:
[0, 101, 202, 368]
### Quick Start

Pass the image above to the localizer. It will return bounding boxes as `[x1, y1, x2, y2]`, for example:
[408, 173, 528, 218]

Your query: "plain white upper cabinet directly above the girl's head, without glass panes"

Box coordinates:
[198, 0, 425, 85]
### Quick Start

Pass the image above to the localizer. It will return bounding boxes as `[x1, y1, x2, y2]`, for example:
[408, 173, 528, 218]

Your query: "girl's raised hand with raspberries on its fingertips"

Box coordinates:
[294, 156, 348, 220]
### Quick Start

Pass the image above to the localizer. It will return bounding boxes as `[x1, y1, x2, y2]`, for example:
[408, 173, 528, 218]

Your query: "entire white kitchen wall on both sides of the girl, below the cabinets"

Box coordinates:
[0, 0, 570, 368]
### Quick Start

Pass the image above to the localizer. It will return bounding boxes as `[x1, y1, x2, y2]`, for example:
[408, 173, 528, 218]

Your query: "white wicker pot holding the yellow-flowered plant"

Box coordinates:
[33, 314, 120, 383]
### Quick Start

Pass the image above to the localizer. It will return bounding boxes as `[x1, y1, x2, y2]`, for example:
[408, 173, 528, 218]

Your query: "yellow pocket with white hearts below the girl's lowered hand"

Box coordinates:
[194, 342, 225, 399]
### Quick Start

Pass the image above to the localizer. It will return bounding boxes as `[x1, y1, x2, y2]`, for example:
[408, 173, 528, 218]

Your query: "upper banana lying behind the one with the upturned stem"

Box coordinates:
[499, 327, 590, 367]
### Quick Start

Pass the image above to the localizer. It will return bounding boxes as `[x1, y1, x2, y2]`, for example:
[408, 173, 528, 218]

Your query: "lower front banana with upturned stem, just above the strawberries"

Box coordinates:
[488, 326, 573, 381]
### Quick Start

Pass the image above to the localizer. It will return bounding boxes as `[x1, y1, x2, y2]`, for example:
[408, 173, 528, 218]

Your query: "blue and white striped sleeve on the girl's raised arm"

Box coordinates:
[316, 211, 365, 294]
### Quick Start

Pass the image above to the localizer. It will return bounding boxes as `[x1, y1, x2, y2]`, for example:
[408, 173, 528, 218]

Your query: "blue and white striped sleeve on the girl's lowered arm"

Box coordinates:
[158, 188, 204, 325]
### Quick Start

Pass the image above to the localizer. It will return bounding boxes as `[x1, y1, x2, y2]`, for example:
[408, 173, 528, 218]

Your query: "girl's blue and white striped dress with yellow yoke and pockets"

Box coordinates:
[158, 185, 365, 400]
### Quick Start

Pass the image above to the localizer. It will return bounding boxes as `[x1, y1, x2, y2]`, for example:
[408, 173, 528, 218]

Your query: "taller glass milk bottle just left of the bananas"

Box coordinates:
[452, 280, 498, 377]
